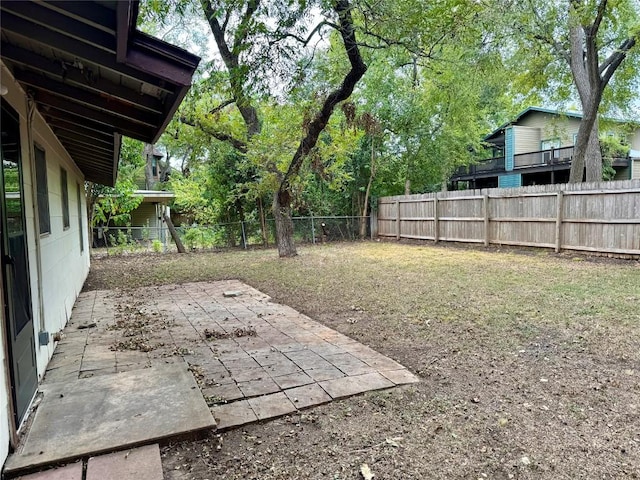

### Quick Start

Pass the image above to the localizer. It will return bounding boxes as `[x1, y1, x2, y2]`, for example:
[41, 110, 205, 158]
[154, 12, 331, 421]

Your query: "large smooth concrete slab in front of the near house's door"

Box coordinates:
[5, 363, 215, 473]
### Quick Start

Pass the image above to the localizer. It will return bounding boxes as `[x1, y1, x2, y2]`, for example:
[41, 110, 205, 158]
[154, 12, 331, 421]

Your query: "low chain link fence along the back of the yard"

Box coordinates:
[93, 217, 371, 253]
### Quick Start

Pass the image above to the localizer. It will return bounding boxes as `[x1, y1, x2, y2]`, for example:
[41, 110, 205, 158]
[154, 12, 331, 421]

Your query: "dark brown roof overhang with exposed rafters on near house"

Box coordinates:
[0, 0, 200, 185]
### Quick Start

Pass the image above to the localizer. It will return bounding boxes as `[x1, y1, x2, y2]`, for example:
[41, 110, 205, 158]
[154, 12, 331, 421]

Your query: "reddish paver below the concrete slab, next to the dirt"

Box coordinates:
[86, 444, 164, 480]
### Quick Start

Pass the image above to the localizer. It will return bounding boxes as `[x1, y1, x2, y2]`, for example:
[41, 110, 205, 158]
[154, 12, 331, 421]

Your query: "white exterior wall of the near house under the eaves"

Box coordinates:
[0, 62, 89, 463]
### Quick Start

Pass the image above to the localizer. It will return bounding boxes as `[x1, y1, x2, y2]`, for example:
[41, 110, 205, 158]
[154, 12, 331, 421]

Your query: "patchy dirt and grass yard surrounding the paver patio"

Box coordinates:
[85, 242, 640, 480]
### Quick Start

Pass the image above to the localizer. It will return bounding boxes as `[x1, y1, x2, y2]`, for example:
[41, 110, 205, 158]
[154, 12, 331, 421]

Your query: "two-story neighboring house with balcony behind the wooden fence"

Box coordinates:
[450, 107, 640, 189]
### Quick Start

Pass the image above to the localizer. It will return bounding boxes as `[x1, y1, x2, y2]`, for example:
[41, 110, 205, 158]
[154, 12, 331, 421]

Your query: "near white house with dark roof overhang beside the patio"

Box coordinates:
[0, 0, 199, 463]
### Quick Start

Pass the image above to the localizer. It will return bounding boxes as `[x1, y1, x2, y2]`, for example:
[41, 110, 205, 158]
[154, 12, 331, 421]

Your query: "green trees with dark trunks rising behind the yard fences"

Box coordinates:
[129, 0, 640, 256]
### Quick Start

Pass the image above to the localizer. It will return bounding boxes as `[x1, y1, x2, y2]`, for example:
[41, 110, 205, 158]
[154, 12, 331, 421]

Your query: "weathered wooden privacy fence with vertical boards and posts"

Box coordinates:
[377, 180, 640, 255]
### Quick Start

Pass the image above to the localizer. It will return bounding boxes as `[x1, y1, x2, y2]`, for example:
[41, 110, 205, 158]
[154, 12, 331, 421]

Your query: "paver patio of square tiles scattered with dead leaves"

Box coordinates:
[44, 280, 418, 429]
